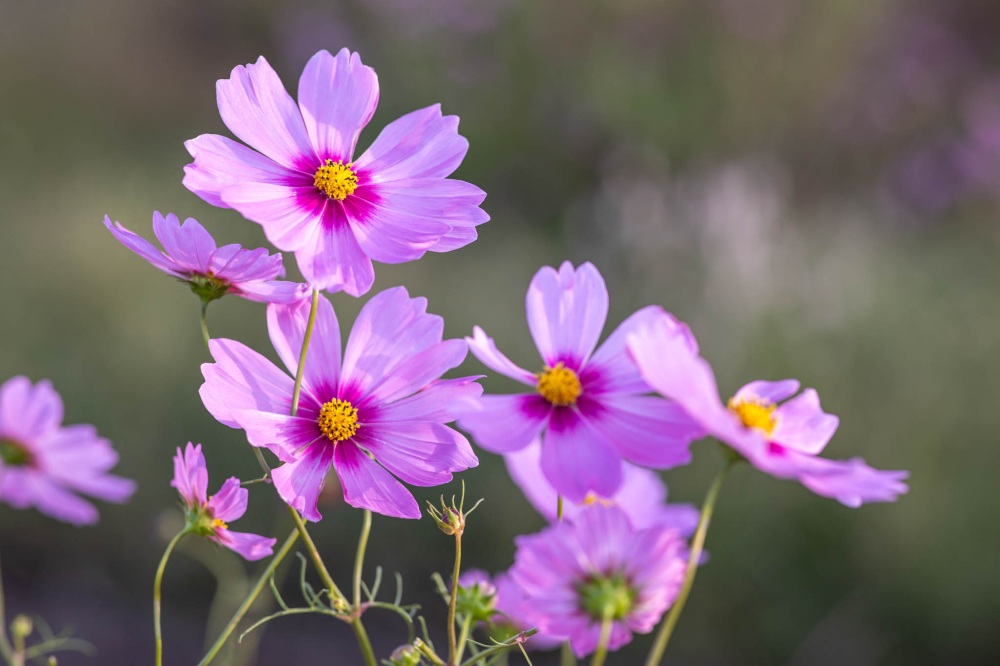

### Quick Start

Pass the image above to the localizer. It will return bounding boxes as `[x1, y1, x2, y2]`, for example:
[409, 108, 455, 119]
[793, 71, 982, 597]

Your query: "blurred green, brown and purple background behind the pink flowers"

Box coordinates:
[0, 0, 1000, 666]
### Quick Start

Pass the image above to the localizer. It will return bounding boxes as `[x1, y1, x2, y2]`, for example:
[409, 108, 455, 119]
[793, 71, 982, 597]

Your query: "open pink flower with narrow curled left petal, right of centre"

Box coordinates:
[459, 261, 704, 503]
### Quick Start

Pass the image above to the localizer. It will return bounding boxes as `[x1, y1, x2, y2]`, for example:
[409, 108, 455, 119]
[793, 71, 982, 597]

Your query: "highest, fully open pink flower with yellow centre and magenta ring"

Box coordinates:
[184, 49, 489, 296]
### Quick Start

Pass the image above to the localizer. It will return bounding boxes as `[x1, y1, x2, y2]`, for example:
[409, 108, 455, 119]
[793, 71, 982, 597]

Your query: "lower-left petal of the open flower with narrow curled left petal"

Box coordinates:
[458, 394, 552, 453]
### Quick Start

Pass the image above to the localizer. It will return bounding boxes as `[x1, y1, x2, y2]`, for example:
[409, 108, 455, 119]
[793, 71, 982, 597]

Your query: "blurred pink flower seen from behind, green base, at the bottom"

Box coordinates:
[508, 505, 687, 657]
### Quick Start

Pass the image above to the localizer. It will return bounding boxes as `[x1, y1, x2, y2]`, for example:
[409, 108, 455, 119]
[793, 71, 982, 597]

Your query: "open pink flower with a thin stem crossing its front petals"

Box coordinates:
[201, 287, 482, 521]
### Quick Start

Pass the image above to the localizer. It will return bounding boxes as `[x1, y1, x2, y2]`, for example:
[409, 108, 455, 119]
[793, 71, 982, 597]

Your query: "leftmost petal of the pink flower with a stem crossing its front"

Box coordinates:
[198, 338, 295, 428]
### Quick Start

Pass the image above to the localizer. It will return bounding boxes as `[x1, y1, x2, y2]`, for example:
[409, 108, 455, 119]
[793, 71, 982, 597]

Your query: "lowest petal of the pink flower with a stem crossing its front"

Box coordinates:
[334, 441, 420, 519]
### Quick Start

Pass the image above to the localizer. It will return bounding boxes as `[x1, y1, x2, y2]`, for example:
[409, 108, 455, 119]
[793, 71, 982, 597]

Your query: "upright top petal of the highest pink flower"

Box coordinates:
[299, 49, 378, 163]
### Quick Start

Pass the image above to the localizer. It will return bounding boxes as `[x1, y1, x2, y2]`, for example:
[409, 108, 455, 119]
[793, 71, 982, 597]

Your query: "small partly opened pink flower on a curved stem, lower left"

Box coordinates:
[170, 442, 276, 561]
